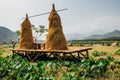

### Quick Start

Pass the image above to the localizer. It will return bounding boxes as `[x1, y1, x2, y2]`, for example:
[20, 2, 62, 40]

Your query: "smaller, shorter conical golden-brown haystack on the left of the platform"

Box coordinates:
[18, 14, 34, 49]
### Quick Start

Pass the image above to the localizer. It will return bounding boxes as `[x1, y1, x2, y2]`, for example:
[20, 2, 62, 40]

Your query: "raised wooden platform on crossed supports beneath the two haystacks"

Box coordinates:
[12, 47, 92, 61]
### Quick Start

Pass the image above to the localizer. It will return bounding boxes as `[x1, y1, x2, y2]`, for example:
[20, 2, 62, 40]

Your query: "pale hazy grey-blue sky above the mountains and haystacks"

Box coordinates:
[0, 0, 120, 34]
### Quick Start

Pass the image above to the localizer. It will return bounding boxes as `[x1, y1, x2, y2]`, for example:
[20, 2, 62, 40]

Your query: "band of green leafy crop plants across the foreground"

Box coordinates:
[0, 56, 120, 80]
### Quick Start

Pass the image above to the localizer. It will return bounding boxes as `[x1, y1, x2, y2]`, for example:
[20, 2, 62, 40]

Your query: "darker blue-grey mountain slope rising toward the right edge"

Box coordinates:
[85, 30, 120, 39]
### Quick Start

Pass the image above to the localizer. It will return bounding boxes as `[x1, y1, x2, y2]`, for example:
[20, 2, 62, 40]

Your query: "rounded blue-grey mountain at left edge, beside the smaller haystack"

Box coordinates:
[0, 26, 18, 43]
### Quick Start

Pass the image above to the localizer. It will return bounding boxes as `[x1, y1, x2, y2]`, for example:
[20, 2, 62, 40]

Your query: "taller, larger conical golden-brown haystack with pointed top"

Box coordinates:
[45, 4, 68, 50]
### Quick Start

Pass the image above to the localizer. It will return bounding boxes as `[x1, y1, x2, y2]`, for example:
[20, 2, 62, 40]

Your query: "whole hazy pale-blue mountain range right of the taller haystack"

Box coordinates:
[65, 30, 120, 40]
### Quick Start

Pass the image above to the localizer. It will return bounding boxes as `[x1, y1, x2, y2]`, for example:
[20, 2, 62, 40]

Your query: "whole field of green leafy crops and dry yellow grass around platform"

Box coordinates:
[0, 46, 120, 80]
